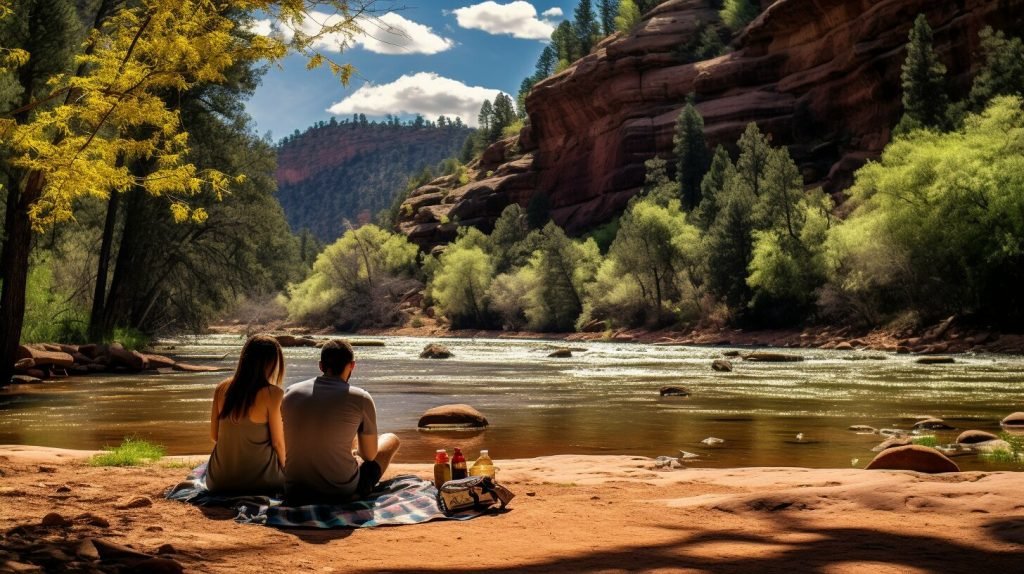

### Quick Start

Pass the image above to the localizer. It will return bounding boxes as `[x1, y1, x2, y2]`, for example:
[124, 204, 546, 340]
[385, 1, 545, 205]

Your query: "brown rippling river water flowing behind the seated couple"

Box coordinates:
[0, 336, 1024, 470]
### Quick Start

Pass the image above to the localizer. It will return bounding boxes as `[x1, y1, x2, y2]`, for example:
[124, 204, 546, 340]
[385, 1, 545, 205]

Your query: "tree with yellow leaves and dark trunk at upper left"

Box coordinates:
[0, 0, 374, 384]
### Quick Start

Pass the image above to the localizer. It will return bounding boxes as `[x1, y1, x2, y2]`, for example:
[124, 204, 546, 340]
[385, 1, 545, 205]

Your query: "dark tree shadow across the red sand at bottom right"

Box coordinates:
[378, 514, 1024, 574]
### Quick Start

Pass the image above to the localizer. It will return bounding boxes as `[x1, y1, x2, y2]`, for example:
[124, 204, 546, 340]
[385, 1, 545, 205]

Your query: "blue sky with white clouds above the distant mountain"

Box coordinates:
[239, 0, 578, 140]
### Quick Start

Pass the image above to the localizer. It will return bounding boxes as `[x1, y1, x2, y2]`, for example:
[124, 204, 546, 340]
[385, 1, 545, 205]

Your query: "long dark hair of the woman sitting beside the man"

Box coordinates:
[220, 335, 285, 421]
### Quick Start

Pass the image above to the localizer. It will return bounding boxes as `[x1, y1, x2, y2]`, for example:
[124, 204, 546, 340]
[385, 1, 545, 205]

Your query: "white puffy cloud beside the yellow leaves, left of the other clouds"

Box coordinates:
[250, 12, 455, 54]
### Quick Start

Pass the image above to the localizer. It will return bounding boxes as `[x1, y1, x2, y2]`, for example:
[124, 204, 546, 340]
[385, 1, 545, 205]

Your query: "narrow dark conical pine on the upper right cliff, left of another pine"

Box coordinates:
[897, 14, 949, 132]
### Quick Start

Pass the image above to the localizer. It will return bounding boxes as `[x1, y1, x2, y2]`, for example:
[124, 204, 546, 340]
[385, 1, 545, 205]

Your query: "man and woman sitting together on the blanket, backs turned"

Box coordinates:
[206, 335, 398, 505]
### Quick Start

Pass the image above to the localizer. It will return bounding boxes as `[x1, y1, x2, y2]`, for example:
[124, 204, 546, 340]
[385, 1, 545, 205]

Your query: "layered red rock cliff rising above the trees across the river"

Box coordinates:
[403, 0, 1024, 246]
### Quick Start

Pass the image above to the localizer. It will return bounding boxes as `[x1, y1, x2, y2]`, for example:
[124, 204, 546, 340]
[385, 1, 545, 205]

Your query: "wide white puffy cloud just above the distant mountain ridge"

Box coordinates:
[328, 72, 501, 126]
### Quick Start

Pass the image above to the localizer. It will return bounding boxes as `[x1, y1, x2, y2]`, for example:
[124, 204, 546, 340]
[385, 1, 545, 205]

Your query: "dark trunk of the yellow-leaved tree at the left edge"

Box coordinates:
[0, 172, 44, 386]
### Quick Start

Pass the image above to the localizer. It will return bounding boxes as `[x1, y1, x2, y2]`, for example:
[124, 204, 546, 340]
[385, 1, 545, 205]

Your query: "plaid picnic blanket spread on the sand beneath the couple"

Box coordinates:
[165, 462, 496, 528]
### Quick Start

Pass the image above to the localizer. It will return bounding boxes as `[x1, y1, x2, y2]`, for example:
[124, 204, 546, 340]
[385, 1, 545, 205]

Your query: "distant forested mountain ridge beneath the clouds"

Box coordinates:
[276, 120, 473, 241]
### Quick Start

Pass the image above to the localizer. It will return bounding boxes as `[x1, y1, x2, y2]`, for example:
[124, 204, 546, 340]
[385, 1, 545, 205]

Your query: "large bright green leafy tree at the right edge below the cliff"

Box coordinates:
[822, 96, 1024, 325]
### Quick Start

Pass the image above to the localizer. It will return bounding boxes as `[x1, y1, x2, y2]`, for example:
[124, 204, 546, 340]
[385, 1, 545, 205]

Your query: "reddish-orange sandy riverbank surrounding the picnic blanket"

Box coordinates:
[0, 446, 1024, 573]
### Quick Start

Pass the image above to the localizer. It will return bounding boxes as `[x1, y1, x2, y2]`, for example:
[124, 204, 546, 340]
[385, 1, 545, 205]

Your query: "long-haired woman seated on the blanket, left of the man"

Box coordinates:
[206, 335, 285, 494]
